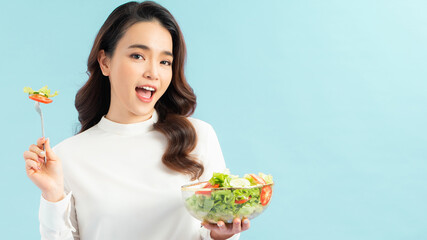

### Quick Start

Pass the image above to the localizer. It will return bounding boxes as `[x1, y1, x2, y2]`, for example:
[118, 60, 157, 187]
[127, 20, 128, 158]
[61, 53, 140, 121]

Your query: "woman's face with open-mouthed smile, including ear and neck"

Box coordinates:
[98, 21, 173, 123]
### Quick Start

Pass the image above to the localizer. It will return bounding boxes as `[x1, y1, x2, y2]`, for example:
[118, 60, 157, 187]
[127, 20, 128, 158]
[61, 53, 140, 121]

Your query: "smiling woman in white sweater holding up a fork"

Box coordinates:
[24, 2, 250, 240]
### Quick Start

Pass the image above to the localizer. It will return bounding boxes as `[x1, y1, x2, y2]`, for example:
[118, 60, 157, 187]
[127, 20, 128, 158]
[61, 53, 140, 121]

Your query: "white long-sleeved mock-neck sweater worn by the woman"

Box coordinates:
[39, 112, 239, 240]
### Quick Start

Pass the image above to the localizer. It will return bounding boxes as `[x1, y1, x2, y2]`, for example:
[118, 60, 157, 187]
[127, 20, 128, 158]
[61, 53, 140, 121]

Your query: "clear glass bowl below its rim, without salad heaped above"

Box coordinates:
[181, 182, 274, 223]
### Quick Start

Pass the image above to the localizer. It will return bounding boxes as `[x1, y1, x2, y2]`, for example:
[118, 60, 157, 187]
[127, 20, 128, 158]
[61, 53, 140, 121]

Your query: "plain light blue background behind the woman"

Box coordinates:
[0, 0, 427, 240]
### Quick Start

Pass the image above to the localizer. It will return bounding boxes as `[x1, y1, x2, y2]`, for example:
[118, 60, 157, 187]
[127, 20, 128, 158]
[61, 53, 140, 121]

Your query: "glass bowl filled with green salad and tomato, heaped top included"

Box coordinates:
[181, 171, 274, 223]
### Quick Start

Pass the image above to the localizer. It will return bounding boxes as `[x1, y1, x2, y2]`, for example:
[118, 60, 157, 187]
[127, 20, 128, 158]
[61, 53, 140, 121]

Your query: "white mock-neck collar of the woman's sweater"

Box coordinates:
[98, 111, 158, 135]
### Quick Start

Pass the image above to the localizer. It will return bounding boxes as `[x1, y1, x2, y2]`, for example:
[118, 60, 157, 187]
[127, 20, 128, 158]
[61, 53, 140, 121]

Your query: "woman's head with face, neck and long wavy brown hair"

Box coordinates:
[75, 2, 203, 182]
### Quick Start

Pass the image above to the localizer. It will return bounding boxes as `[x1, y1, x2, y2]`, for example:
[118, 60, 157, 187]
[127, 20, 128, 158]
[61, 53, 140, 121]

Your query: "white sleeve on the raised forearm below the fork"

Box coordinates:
[39, 192, 79, 240]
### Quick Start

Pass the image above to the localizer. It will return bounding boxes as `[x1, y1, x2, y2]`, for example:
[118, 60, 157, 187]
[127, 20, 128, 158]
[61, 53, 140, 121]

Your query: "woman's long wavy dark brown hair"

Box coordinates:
[75, 1, 204, 180]
